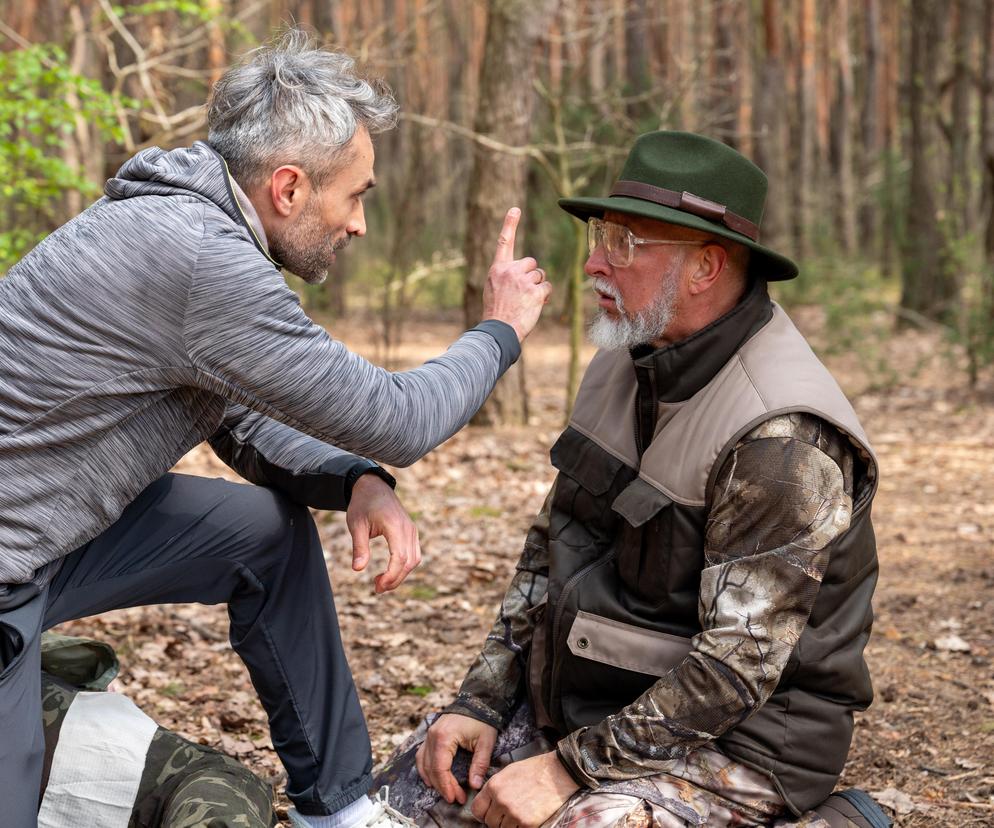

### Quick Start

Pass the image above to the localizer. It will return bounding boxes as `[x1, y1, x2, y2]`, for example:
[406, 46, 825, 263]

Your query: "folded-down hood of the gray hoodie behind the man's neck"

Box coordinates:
[104, 141, 281, 267]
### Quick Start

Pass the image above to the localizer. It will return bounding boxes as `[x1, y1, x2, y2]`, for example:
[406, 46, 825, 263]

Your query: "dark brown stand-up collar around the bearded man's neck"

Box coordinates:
[631, 279, 773, 403]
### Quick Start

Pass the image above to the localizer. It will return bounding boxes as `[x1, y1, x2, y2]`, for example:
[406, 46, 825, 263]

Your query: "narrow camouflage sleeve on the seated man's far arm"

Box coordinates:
[443, 484, 555, 730]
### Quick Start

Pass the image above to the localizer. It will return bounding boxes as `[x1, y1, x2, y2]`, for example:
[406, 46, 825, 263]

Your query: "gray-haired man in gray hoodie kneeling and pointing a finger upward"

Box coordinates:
[0, 33, 550, 828]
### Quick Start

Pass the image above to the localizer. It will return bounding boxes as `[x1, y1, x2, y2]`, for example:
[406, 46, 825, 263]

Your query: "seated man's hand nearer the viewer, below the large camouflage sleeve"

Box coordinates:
[472, 751, 580, 828]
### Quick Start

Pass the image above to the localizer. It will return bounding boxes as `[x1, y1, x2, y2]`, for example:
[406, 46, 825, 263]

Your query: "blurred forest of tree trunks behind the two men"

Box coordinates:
[0, 0, 994, 414]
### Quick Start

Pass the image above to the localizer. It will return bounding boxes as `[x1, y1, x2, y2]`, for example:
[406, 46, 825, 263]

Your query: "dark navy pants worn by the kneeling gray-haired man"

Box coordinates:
[0, 474, 372, 828]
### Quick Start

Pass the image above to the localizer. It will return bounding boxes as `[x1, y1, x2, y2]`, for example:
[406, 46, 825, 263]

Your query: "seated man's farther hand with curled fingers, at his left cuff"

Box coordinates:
[415, 713, 497, 805]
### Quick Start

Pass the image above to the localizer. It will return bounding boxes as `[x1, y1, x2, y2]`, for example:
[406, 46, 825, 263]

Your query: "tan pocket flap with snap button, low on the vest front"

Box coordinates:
[566, 610, 693, 676]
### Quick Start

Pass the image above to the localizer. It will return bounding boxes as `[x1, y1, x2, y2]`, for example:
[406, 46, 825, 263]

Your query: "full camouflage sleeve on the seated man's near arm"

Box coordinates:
[558, 414, 854, 788]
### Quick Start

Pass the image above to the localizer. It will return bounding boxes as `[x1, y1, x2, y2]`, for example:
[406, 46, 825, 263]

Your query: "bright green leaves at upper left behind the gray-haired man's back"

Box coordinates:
[0, 44, 127, 273]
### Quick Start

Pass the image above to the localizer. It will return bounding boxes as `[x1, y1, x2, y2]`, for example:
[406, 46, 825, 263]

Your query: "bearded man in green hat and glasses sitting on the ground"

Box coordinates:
[378, 132, 886, 828]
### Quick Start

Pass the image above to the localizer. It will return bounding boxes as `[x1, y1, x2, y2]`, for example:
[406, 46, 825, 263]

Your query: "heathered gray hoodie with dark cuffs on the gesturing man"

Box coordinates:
[0, 142, 519, 606]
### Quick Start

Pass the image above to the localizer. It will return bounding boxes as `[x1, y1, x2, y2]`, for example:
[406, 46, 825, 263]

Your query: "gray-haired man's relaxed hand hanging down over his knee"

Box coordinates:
[345, 474, 421, 592]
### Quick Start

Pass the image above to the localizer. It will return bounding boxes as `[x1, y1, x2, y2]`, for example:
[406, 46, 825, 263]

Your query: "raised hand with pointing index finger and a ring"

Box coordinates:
[483, 207, 552, 342]
